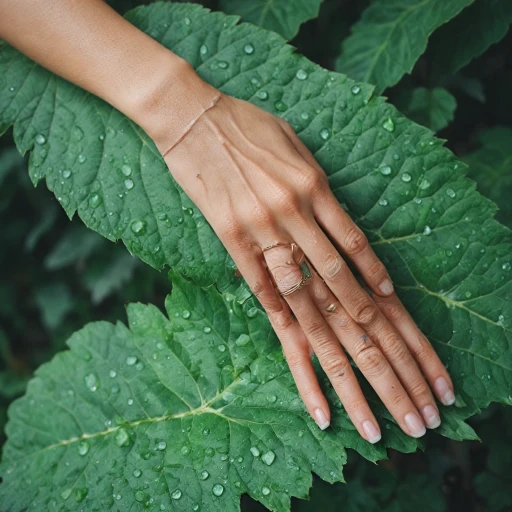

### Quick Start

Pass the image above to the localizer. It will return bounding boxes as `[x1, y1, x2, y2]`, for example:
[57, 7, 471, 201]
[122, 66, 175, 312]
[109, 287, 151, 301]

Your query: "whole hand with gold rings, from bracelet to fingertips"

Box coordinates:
[159, 90, 454, 443]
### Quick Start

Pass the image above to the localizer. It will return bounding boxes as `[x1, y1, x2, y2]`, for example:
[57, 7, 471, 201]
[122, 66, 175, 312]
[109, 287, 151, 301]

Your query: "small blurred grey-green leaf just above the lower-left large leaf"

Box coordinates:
[84, 250, 140, 304]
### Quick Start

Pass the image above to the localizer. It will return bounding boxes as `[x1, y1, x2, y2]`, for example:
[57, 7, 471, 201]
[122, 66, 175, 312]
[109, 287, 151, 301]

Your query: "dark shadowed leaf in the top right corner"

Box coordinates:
[430, 0, 512, 77]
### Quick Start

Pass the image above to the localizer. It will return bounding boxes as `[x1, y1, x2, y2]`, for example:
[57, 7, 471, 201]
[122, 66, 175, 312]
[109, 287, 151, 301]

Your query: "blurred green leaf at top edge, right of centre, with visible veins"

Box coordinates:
[336, 0, 473, 93]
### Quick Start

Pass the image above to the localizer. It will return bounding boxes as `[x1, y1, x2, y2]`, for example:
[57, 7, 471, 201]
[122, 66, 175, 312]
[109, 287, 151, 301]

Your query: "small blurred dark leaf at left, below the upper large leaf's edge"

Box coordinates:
[44, 223, 104, 270]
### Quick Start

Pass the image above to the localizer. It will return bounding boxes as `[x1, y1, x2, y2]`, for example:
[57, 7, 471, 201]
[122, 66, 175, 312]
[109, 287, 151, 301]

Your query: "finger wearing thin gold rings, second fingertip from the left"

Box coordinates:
[265, 243, 380, 443]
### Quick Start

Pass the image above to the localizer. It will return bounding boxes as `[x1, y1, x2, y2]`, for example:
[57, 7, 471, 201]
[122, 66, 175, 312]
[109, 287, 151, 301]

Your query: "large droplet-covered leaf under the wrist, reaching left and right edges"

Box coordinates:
[0, 3, 512, 500]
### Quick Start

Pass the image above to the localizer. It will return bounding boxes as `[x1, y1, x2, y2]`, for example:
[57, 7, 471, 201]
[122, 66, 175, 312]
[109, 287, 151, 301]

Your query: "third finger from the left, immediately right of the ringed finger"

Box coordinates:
[310, 262, 425, 437]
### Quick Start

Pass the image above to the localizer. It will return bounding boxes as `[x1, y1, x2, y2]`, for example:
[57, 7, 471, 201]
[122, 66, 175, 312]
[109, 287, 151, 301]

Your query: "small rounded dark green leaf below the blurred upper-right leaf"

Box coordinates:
[396, 87, 457, 132]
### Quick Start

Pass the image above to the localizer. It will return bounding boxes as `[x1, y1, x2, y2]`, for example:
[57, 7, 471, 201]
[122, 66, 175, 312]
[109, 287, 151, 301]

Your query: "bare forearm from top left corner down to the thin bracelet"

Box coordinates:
[0, 0, 217, 150]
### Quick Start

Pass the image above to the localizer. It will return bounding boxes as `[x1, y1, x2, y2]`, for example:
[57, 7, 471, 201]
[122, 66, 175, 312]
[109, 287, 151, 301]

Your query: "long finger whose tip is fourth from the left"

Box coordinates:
[291, 220, 440, 428]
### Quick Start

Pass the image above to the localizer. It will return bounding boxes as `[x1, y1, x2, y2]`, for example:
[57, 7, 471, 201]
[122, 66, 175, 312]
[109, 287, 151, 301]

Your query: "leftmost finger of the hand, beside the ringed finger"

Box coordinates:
[227, 244, 330, 430]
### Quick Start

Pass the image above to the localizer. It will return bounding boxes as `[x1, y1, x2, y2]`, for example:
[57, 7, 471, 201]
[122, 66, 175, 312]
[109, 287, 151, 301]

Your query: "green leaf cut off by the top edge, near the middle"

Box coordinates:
[220, 0, 323, 40]
